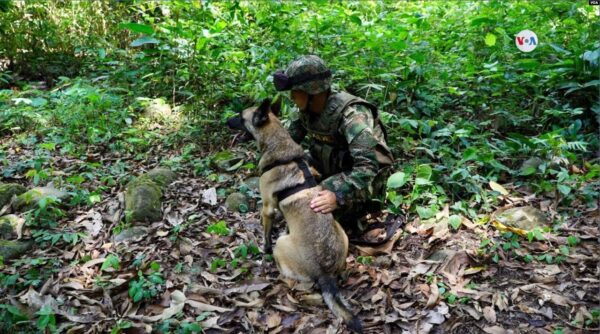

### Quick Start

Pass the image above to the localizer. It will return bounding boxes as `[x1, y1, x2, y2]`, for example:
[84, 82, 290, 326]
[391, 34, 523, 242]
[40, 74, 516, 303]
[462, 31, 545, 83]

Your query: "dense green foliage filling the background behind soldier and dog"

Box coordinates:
[0, 1, 600, 227]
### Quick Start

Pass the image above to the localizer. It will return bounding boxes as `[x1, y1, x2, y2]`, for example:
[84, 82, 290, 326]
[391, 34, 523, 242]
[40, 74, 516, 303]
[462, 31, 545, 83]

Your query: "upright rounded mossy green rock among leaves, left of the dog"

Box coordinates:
[125, 175, 162, 223]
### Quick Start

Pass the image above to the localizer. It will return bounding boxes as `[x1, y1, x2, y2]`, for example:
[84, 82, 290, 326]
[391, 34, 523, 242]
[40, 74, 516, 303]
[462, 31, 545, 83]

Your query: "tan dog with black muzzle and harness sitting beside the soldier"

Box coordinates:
[227, 99, 362, 333]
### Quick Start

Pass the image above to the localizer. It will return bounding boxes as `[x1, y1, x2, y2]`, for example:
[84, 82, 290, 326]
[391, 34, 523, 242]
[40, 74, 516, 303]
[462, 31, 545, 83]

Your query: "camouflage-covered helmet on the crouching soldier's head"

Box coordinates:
[285, 55, 331, 95]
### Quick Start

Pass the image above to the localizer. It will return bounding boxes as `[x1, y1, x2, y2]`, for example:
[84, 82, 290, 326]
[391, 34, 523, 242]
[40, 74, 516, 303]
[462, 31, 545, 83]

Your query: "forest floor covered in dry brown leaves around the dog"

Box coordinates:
[0, 116, 600, 334]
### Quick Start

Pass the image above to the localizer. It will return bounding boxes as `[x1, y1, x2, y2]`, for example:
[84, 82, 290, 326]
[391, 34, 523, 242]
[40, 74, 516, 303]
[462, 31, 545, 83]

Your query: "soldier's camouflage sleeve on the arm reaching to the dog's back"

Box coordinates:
[321, 106, 379, 207]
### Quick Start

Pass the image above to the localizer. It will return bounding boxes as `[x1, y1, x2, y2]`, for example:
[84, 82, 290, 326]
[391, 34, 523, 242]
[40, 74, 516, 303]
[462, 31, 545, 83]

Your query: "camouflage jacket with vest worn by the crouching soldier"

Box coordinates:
[289, 92, 393, 208]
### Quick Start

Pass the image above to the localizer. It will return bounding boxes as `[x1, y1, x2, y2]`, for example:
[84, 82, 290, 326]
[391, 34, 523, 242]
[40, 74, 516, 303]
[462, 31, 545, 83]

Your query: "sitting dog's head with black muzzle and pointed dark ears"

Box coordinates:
[227, 98, 281, 139]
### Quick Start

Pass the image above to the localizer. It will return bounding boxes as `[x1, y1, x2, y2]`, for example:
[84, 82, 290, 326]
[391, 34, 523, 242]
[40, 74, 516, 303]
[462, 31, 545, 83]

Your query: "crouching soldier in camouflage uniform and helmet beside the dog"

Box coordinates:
[273, 55, 393, 229]
